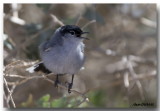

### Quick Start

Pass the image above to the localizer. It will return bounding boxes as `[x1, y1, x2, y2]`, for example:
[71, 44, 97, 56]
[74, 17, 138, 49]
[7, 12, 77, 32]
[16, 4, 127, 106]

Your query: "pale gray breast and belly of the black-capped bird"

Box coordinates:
[40, 43, 84, 74]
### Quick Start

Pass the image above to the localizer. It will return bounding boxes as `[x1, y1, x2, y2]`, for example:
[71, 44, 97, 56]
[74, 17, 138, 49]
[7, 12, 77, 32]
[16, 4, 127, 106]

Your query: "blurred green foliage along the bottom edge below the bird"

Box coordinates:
[21, 90, 114, 108]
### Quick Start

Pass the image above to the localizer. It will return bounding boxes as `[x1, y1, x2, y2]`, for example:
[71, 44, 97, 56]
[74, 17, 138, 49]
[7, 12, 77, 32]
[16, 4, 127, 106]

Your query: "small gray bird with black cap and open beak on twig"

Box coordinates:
[27, 25, 89, 93]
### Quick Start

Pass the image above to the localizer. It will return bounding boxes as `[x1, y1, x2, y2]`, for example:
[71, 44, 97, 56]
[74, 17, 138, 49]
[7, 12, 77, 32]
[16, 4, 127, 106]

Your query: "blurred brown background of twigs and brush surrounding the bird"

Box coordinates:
[3, 4, 158, 108]
